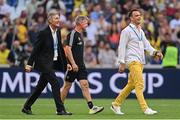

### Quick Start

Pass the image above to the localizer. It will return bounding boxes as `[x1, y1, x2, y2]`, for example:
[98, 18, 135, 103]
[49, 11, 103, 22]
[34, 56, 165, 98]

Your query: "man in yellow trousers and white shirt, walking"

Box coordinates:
[111, 9, 163, 115]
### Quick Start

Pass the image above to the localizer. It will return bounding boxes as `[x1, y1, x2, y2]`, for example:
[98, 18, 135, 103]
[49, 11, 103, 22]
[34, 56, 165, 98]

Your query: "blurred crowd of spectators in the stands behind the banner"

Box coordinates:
[0, 0, 180, 68]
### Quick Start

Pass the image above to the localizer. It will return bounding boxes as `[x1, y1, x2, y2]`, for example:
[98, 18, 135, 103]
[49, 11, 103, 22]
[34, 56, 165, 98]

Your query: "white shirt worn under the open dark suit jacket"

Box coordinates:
[49, 26, 58, 61]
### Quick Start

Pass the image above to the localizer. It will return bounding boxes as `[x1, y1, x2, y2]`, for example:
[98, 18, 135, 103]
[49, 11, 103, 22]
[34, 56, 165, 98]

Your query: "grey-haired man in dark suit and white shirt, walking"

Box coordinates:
[22, 10, 72, 115]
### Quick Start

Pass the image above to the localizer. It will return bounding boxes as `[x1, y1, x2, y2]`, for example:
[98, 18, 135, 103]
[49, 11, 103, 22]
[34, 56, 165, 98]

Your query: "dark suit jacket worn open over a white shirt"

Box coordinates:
[28, 26, 67, 73]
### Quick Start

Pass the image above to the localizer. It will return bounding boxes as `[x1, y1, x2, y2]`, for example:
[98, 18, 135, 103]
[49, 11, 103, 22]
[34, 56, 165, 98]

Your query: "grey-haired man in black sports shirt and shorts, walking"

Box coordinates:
[61, 16, 104, 114]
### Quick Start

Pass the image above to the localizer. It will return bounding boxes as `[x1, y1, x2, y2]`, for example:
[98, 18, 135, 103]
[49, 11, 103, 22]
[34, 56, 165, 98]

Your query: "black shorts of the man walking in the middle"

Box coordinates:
[65, 68, 88, 82]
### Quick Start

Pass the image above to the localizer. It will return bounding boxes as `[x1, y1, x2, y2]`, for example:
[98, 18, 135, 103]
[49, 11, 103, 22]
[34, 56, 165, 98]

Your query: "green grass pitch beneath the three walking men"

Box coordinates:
[0, 98, 180, 120]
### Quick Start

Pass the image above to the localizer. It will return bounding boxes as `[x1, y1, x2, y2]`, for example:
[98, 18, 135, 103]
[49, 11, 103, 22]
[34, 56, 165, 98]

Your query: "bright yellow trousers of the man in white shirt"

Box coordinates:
[112, 61, 148, 112]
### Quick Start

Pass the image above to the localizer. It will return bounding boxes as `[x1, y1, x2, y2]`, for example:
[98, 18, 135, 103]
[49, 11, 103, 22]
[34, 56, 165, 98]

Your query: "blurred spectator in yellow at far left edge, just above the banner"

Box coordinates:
[0, 42, 10, 65]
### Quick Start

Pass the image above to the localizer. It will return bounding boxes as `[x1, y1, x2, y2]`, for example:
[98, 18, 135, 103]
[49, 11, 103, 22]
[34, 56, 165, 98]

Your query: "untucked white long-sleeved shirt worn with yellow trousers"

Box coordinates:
[118, 23, 156, 64]
